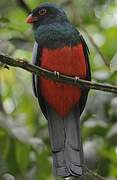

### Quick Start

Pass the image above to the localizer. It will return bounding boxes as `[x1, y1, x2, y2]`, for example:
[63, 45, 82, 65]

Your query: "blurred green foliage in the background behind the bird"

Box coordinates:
[0, 0, 117, 180]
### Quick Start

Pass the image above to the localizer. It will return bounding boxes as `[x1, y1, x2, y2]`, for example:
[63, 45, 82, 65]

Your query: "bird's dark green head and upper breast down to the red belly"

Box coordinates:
[27, 3, 78, 48]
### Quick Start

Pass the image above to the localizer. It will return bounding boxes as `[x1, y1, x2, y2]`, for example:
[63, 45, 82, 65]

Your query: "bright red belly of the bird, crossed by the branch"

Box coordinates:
[39, 44, 86, 118]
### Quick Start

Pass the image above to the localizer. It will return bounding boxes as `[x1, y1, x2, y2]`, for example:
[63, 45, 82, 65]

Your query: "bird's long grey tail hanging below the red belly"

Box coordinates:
[47, 107, 85, 180]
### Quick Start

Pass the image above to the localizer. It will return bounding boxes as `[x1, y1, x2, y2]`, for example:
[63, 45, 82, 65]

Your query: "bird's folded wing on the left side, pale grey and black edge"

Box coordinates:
[32, 42, 47, 119]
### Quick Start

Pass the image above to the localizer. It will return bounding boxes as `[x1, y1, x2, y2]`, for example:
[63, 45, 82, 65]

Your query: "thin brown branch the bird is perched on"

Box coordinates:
[0, 54, 117, 94]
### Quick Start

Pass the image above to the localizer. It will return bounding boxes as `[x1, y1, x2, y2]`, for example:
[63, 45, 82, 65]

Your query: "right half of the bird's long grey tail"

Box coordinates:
[64, 107, 84, 176]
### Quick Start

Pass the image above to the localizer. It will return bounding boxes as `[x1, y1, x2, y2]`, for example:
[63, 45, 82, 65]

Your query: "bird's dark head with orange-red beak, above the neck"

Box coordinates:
[27, 3, 68, 27]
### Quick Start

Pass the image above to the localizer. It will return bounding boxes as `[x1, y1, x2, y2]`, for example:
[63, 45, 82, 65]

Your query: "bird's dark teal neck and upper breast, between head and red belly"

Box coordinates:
[34, 22, 78, 49]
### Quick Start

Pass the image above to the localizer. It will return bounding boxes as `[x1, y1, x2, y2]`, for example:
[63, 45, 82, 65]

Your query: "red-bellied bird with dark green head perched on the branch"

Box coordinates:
[27, 3, 91, 178]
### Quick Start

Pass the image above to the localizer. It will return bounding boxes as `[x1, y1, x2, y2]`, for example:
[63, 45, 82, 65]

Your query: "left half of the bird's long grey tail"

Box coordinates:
[47, 106, 70, 177]
